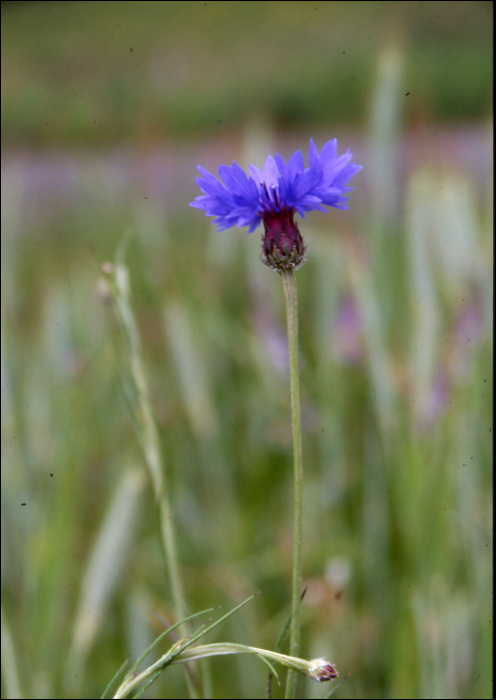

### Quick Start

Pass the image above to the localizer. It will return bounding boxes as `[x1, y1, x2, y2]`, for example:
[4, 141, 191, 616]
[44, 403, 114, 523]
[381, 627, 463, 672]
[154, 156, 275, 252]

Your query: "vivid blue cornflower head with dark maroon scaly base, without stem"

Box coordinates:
[191, 139, 362, 270]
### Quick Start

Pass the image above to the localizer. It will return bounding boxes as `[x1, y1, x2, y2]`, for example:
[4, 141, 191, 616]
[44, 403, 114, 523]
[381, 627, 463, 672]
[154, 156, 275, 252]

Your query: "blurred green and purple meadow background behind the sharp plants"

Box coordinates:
[2, 0, 493, 698]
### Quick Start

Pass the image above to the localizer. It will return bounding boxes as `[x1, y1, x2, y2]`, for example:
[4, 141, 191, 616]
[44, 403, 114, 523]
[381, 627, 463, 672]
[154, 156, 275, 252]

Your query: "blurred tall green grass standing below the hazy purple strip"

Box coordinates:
[2, 35, 492, 698]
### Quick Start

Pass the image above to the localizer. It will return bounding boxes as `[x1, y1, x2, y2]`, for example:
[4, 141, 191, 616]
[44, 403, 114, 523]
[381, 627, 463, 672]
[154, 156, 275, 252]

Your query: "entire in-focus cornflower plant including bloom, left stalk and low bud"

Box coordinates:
[102, 139, 362, 698]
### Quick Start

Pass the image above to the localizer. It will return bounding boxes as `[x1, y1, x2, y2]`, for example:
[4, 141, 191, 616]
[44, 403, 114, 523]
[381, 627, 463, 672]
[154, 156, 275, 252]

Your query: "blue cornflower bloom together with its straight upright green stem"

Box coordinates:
[191, 139, 362, 698]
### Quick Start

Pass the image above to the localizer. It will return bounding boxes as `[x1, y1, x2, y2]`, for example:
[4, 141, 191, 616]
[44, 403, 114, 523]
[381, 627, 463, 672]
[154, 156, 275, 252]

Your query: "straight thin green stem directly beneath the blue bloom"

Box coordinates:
[281, 270, 303, 698]
